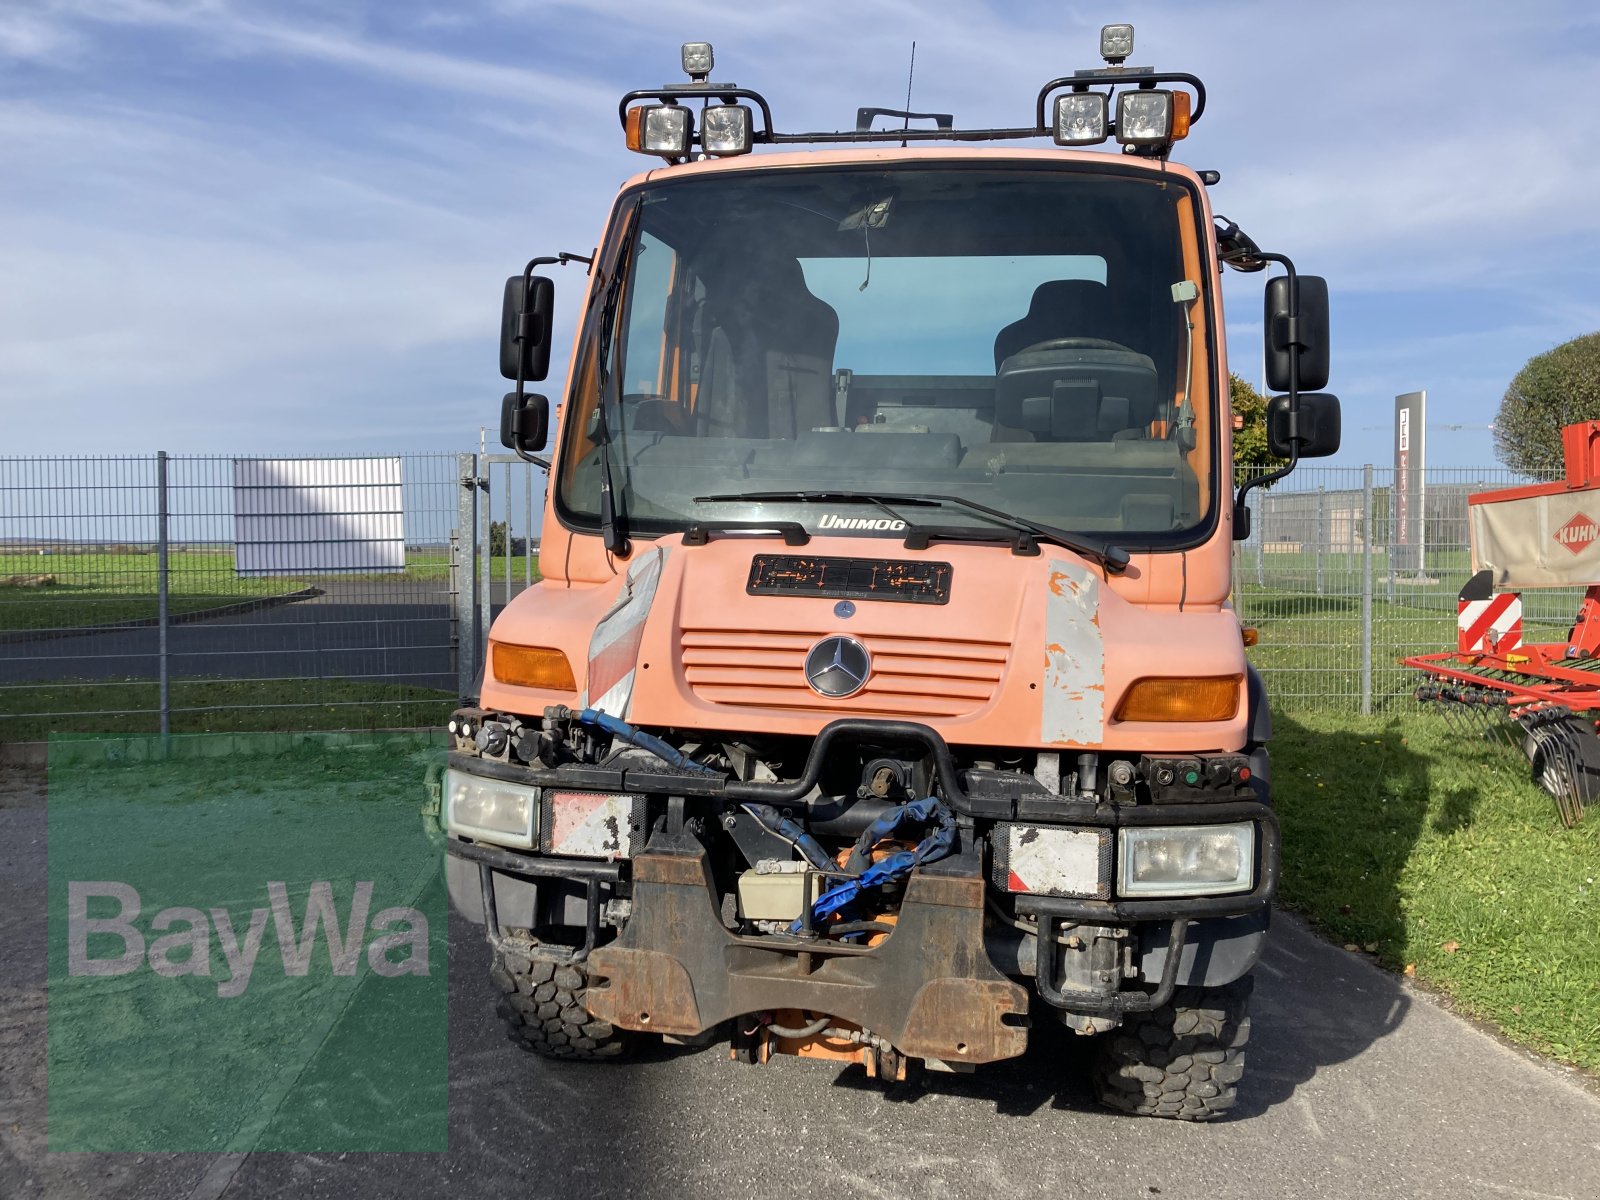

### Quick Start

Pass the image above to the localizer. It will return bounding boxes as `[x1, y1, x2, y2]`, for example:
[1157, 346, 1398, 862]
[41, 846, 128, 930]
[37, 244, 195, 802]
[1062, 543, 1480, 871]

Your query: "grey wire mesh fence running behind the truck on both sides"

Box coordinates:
[0, 454, 1579, 741]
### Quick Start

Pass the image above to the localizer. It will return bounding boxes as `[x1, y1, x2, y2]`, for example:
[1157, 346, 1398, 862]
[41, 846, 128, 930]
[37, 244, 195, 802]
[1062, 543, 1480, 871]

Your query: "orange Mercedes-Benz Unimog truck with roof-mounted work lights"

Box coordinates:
[443, 26, 1338, 1120]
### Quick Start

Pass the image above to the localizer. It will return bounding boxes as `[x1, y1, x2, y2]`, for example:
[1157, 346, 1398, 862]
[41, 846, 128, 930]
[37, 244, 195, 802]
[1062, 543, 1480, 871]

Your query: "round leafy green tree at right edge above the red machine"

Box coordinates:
[1494, 333, 1600, 475]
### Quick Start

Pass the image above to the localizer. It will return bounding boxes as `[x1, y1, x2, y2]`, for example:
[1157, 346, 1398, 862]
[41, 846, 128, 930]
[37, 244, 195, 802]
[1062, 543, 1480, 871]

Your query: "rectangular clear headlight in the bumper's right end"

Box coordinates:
[1117, 821, 1256, 896]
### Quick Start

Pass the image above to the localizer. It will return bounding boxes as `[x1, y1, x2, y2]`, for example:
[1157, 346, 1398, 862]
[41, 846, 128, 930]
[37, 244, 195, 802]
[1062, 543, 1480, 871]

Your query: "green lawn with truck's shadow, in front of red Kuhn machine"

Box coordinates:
[1272, 712, 1600, 1070]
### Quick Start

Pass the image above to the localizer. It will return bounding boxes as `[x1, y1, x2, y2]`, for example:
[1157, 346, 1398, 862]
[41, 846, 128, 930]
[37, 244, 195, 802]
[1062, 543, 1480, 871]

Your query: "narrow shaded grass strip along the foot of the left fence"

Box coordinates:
[0, 678, 456, 741]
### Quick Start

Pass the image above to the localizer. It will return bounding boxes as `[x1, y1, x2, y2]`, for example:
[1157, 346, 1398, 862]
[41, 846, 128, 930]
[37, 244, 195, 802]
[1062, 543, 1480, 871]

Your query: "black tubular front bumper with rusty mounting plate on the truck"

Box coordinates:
[448, 722, 1280, 1062]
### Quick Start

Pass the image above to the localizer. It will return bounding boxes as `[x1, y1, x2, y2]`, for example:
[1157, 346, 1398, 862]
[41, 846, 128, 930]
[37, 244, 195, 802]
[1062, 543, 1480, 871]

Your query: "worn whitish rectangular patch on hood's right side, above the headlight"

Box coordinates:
[1040, 558, 1106, 746]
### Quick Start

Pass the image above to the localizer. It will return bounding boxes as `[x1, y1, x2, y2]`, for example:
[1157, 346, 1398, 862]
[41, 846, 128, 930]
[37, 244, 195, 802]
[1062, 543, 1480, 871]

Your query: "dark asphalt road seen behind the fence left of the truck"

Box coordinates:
[0, 579, 499, 691]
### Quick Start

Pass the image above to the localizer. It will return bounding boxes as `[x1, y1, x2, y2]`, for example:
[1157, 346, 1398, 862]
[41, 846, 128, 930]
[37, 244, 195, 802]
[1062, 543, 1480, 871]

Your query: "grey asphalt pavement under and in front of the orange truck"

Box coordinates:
[0, 771, 1600, 1200]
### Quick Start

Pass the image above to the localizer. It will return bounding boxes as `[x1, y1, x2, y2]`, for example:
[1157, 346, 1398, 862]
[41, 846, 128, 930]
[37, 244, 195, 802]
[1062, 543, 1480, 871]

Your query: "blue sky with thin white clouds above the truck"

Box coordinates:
[0, 0, 1600, 467]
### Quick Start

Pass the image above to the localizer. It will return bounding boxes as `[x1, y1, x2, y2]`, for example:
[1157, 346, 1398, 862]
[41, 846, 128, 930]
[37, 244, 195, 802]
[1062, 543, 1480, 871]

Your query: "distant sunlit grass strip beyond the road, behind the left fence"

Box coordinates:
[0, 549, 541, 630]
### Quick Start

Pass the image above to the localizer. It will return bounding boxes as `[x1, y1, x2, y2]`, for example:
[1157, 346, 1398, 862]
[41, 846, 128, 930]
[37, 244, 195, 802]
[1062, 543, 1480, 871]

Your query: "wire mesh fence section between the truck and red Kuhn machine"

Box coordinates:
[1234, 467, 1582, 712]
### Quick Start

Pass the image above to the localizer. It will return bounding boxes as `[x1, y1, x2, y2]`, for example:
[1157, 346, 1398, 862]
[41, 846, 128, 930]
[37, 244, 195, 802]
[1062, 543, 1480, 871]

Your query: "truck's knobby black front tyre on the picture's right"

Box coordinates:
[1094, 974, 1254, 1122]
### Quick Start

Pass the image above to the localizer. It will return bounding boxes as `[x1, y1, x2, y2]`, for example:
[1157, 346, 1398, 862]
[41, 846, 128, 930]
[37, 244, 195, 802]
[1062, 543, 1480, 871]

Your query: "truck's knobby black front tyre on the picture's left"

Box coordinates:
[490, 950, 632, 1059]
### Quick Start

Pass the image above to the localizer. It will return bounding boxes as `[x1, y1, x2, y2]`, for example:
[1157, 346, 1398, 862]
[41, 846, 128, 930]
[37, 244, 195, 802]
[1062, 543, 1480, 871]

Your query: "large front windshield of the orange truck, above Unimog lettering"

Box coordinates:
[558, 166, 1216, 546]
